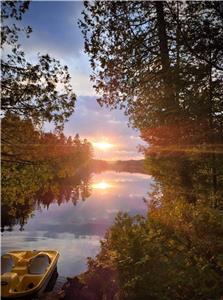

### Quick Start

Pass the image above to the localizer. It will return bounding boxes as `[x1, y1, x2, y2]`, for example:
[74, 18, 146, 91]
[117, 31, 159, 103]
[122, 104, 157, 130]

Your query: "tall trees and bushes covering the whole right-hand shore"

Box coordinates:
[80, 1, 223, 300]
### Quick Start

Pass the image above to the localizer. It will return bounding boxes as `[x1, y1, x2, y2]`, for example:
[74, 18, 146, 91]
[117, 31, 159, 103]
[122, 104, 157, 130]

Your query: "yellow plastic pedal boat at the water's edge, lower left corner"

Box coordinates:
[1, 250, 59, 298]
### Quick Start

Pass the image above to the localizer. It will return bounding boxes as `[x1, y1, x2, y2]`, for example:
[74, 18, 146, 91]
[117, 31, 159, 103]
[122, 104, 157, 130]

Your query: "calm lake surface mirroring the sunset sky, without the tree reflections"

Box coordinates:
[2, 171, 152, 276]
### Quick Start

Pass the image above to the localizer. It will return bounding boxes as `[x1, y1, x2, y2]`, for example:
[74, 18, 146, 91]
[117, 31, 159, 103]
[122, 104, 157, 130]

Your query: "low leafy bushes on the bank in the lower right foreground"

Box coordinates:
[88, 201, 223, 300]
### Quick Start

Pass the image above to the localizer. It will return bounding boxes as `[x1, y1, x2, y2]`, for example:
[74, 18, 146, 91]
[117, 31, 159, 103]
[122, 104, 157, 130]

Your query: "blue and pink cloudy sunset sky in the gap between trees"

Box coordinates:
[20, 1, 143, 160]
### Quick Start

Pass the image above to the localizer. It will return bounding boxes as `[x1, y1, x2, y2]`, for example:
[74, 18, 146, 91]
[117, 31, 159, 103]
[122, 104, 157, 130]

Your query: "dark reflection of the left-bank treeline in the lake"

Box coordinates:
[1, 171, 91, 232]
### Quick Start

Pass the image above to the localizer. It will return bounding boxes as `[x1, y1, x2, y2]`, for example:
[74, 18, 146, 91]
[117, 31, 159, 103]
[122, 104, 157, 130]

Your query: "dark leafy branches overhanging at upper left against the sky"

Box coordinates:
[1, 1, 76, 128]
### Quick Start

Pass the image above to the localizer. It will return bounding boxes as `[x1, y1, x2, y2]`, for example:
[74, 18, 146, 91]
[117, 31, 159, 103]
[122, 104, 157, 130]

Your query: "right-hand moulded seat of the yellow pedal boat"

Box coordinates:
[28, 254, 50, 275]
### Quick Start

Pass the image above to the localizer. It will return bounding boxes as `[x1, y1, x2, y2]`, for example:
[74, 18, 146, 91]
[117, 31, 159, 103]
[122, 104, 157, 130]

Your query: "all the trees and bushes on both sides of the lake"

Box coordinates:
[1, 1, 223, 300]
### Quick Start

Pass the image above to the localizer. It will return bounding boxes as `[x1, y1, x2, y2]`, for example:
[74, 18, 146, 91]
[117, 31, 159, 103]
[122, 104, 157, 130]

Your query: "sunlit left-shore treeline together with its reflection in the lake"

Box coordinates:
[1, 113, 93, 228]
